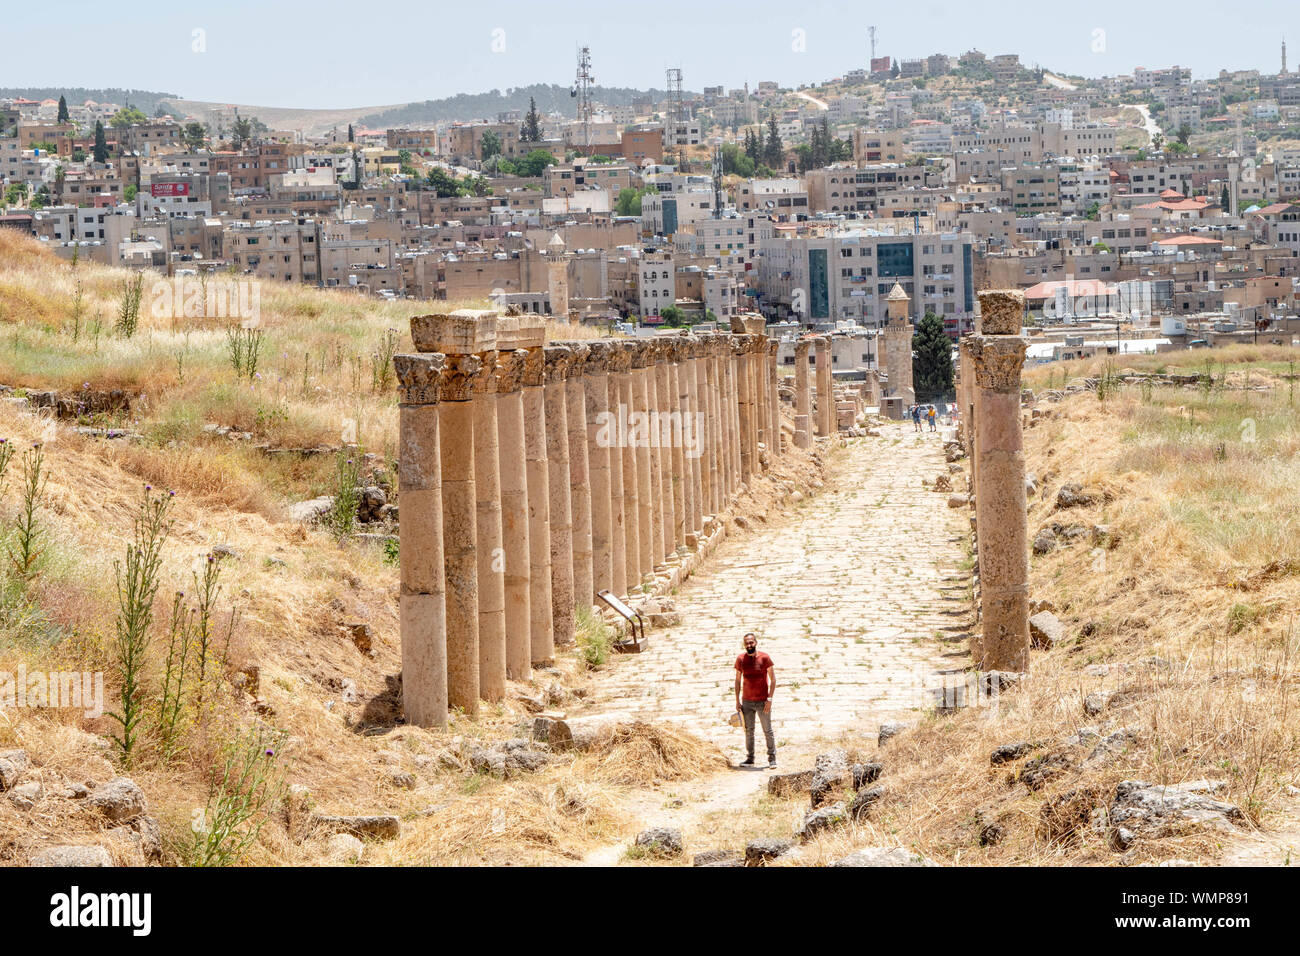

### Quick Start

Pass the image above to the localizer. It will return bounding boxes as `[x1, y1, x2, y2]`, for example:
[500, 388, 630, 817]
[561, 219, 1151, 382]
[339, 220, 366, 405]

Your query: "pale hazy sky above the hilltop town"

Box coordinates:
[0, 0, 1300, 108]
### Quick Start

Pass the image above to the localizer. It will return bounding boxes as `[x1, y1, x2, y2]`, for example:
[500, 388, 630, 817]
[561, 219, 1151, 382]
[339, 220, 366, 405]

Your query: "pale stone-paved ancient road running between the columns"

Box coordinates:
[593, 423, 970, 756]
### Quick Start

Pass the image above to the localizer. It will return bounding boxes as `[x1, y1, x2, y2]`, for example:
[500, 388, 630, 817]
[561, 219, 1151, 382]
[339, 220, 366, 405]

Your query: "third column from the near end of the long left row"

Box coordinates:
[473, 351, 506, 702]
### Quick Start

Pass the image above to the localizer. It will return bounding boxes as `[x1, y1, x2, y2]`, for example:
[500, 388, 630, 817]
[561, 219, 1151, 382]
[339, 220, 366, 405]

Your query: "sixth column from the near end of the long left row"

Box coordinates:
[545, 345, 573, 645]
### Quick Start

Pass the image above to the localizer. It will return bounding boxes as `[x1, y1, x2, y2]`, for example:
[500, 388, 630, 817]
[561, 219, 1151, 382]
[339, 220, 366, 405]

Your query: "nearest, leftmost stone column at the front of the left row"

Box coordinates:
[393, 355, 447, 727]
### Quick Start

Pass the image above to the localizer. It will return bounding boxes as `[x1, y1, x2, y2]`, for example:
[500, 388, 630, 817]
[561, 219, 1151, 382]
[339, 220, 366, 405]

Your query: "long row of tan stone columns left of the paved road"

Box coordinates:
[394, 310, 781, 726]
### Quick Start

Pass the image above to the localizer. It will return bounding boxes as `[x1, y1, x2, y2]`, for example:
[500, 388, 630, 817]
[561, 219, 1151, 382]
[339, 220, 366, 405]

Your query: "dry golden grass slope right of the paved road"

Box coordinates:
[764, 347, 1300, 865]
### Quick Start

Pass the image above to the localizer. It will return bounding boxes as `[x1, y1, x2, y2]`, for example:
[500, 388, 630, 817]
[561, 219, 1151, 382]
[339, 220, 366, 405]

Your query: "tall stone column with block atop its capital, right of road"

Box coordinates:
[971, 290, 1030, 671]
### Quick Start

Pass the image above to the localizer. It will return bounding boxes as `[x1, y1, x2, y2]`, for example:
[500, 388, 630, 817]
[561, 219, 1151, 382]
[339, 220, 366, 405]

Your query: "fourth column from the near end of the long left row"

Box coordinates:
[493, 349, 533, 680]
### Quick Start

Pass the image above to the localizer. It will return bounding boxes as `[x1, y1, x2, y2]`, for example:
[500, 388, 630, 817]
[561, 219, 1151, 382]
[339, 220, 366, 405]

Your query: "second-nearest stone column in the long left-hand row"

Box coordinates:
[438, 355, 484, 717]
